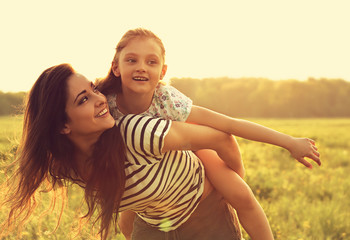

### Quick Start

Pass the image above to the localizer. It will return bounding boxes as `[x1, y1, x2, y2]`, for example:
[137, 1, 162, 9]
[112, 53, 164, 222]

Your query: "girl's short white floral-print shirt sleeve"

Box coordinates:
[148, 84, 192, 122]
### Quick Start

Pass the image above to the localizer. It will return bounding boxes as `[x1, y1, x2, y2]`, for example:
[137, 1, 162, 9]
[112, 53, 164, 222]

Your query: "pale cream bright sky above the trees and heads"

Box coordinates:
[0, 0, 350, 92]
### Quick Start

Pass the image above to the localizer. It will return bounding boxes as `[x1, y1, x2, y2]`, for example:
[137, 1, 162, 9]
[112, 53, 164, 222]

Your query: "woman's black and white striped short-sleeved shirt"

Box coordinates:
[117, 115, 204, 231]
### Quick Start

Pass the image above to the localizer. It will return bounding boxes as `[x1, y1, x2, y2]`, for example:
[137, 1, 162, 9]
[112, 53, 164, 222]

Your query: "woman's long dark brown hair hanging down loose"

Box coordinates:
[0, 64, 125, 239]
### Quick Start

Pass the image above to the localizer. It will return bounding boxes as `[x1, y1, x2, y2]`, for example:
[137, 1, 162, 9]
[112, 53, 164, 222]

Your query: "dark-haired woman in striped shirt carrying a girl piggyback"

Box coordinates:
[2, 64, 245, 240]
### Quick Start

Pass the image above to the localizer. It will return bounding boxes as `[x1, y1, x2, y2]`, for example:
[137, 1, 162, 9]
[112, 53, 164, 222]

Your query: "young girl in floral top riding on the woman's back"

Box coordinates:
[99, 29, 320, 240]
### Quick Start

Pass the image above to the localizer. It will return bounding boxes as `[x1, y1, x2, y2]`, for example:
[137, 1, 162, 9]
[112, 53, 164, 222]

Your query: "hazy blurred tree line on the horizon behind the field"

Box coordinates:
[0, 77, 350, 118]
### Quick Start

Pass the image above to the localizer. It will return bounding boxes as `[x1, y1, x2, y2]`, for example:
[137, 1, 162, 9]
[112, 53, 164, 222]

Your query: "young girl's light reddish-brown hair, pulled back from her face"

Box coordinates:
[96, 28, 165, 95]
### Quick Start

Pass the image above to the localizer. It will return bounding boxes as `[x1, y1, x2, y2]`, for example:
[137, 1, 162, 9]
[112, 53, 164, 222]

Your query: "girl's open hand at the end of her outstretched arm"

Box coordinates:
[288, 137, 321, 169]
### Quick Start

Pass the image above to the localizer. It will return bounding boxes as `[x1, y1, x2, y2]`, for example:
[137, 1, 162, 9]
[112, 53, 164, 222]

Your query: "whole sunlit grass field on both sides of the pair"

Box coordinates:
[0, 117, 350, 240]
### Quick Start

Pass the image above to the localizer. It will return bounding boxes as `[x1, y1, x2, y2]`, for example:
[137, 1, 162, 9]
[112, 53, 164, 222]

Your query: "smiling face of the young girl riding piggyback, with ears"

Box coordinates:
[112, 37, 167, 94]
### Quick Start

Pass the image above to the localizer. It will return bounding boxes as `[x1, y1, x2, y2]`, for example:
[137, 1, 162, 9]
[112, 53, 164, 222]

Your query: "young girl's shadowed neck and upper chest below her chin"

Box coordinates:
[116, 93, 153, 114]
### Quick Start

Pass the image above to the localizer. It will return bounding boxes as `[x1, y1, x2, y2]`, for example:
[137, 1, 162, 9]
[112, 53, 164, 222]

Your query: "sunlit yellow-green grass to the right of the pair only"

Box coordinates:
[238, 119, 350, 240]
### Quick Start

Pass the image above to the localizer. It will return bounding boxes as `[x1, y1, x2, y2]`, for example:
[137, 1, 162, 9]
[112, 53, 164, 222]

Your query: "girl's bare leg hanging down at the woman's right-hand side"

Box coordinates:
[196, 150, 274, 240]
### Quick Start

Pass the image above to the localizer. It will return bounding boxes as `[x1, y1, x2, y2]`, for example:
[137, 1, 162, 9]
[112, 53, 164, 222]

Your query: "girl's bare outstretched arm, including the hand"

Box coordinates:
[187, 106, 321, 168]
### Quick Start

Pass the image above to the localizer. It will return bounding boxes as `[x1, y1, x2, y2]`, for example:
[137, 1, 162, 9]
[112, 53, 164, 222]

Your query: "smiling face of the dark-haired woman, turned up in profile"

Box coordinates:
[61, 74, 115, 137]
